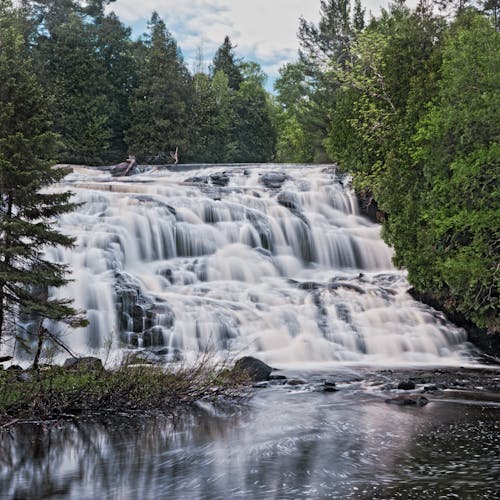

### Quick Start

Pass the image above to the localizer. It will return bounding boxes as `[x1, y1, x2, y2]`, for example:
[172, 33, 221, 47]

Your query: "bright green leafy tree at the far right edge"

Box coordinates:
[408, 13, 500, 331]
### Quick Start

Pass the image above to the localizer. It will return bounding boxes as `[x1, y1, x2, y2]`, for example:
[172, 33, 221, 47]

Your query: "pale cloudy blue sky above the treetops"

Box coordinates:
[108, 0, 400, 90]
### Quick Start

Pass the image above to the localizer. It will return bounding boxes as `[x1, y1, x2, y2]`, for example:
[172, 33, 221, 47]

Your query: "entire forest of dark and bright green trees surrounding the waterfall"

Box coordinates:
[0, 0, 500, 340]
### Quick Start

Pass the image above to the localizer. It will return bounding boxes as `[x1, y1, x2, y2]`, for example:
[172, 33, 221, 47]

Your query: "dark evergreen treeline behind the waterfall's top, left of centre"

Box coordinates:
[0, 0, 276, 164]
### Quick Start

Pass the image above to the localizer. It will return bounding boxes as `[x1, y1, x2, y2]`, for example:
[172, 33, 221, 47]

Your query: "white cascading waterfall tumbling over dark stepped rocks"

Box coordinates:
[43, 165, 465, 363]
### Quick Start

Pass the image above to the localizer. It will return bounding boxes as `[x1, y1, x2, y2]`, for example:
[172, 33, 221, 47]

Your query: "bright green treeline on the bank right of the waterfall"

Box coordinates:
[276, 0, 500, 331]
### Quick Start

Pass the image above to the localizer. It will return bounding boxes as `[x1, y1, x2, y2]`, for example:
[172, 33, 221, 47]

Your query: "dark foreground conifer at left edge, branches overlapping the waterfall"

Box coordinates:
[0, 2, 85, 350]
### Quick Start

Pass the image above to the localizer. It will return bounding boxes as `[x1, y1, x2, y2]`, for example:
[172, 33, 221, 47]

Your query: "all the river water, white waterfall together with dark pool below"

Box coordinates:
[0, 165, 500, 499]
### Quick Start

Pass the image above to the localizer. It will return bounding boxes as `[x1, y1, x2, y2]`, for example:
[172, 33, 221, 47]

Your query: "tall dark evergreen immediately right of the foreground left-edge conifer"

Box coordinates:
[34, 0, 113, 164]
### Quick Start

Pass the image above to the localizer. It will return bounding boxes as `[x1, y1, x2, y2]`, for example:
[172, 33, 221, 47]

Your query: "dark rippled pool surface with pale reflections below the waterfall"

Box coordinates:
[0, 380, 500, 499]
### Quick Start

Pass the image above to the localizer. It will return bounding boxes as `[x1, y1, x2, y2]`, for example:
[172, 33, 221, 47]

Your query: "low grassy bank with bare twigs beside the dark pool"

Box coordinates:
[0, 355, 248, 427]
